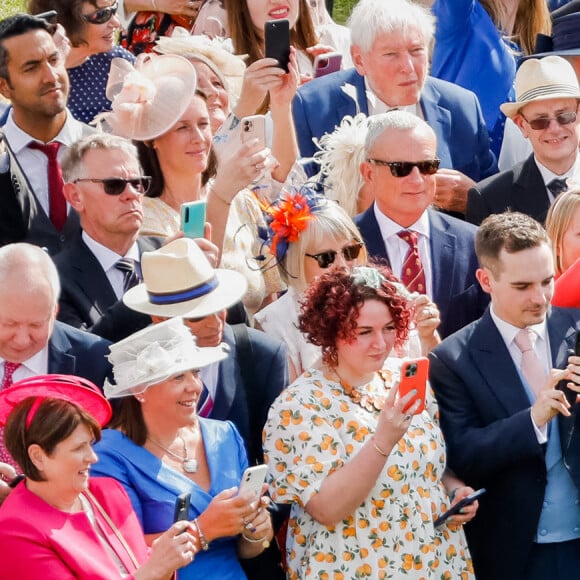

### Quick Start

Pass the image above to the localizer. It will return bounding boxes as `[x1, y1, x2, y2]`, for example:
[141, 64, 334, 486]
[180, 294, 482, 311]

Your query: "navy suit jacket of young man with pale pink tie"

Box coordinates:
[430, 308, 580, 580]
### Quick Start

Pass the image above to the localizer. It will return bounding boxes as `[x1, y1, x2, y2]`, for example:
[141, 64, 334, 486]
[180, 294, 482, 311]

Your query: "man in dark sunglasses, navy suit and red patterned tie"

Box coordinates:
[355, 111, 488, 337]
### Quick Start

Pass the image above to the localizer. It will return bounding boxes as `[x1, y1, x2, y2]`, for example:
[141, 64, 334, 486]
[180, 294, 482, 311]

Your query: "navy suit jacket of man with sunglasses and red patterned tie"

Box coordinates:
[354, 204, 489, 337]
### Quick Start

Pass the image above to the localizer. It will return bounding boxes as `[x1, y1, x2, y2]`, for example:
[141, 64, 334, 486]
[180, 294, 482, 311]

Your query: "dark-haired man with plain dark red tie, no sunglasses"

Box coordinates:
[0, 14, 94, 254]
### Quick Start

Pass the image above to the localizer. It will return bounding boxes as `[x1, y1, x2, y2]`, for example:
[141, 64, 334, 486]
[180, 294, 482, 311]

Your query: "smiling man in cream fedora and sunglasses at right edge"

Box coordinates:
[466, 56, 580, 224]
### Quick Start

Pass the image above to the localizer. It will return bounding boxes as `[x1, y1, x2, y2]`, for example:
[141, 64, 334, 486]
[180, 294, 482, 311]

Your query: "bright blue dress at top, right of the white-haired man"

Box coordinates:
[431, 0, 517, 157]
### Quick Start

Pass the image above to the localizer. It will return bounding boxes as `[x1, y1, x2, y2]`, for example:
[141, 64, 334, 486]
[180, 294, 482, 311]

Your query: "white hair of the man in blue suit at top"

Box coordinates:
[348, 0, 435, 52]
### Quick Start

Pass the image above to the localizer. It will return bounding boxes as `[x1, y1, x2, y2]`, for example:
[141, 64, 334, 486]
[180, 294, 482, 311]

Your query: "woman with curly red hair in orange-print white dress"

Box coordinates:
[264, 266, 477, 580]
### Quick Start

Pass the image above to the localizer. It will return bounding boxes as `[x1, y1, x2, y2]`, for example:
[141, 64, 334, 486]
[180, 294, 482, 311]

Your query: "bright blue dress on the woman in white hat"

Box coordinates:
[91, 419, 248, 580]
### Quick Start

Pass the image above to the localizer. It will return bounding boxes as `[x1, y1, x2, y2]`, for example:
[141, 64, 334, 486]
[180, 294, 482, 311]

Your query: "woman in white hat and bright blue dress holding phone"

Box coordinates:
[92, 318, 273, 580]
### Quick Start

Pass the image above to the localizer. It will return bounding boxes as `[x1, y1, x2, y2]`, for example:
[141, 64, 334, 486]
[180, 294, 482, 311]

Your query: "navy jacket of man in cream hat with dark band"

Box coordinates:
[211, 324, 288, 465]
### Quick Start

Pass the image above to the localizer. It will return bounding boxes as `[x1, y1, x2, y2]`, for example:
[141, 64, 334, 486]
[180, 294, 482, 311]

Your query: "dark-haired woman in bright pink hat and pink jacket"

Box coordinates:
[0, 375, 199, 580]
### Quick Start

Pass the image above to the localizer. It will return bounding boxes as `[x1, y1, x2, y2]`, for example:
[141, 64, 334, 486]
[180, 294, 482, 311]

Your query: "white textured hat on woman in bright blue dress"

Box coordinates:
[104, 318, 227, 399]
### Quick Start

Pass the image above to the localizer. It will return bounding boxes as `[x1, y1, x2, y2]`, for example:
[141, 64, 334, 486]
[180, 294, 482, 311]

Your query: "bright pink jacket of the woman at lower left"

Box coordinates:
[0, 477, 148, 580]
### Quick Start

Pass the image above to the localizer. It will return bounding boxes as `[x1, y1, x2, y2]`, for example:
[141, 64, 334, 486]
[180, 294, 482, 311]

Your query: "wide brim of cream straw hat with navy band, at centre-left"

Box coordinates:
[123, 269, 248, 318]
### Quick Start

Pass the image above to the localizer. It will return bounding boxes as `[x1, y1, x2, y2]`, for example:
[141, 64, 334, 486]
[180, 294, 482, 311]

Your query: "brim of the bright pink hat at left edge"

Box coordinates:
[0, 375, 112, 427]
